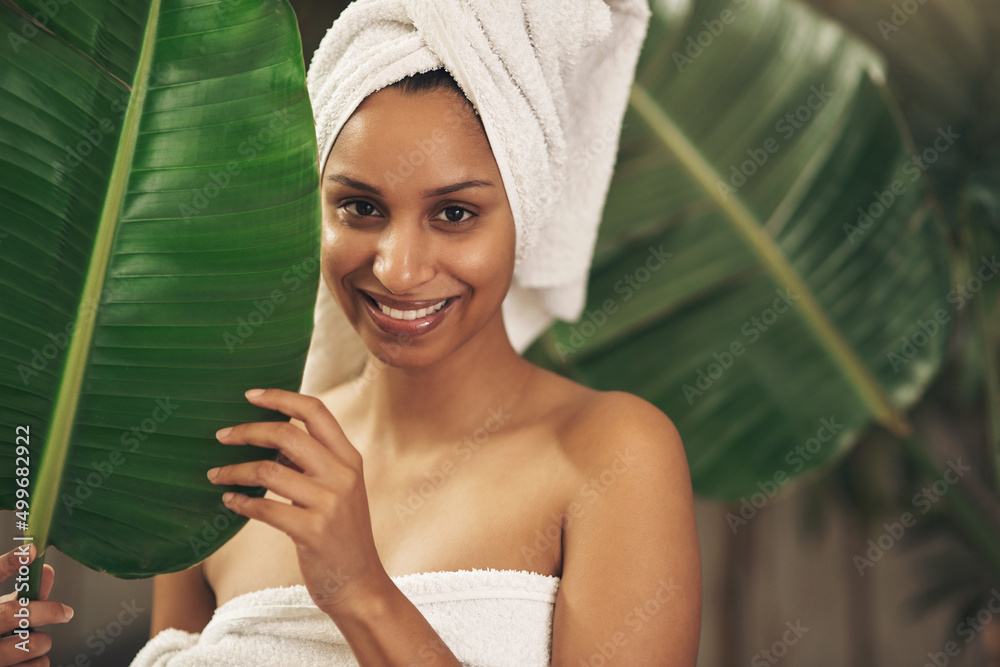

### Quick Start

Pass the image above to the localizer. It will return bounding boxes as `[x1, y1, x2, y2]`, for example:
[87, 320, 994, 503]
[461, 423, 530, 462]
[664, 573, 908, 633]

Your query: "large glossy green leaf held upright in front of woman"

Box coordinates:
[0, 0, 320, 583]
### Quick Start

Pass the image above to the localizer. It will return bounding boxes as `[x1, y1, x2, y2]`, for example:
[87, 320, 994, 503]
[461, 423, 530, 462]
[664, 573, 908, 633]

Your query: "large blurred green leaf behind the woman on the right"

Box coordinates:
[527, 0, 957, 500]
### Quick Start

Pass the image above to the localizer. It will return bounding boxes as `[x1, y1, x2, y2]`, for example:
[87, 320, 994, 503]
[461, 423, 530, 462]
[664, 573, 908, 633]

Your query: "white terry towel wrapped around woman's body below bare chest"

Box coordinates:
[132, 569, 560, 667]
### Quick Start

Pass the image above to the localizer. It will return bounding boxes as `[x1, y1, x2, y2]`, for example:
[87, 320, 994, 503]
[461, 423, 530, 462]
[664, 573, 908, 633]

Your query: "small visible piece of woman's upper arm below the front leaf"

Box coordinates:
[149, 563, 215, 639]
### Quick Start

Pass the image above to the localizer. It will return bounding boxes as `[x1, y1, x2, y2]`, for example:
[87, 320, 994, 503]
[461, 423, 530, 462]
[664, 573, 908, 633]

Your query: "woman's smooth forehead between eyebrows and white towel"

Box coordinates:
[325, 88, 500, 186]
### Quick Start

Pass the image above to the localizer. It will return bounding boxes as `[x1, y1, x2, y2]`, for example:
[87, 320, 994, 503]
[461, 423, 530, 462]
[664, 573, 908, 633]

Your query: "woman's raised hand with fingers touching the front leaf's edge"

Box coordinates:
[208, 389, 392, 620]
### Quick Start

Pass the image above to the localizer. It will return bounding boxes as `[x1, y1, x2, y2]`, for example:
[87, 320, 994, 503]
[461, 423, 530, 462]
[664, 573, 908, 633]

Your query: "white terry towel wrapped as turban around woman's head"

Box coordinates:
[302, 0, 650, 394]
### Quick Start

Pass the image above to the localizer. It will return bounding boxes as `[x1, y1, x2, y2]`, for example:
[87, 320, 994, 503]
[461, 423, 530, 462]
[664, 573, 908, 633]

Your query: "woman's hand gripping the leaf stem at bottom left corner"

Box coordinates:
[0, 544, 73, 667]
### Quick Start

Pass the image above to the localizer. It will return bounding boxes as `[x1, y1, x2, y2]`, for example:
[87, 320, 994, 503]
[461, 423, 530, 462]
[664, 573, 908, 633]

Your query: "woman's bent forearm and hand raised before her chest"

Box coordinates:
[209, 389, 460, 667]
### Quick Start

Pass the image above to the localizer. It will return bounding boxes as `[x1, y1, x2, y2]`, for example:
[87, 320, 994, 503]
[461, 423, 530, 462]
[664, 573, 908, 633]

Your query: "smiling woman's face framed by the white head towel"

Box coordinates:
[322, 88, 515, 367]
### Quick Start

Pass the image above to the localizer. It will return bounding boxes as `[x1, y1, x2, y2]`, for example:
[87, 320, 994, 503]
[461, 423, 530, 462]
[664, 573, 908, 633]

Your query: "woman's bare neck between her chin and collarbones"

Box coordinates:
[356, 313, 532, 455]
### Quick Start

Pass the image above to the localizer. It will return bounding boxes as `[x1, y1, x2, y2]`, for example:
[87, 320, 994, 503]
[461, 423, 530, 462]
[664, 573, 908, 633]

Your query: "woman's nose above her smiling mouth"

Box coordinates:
[372, 218, 434, 294]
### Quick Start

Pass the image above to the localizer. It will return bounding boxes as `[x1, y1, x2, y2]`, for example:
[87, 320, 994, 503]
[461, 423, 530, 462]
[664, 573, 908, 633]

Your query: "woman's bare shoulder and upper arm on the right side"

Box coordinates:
[552, 392, 701, 667]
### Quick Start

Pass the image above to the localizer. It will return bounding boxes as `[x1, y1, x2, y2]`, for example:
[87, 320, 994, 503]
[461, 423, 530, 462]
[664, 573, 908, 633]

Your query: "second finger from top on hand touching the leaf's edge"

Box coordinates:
[216, 422, 347, 477]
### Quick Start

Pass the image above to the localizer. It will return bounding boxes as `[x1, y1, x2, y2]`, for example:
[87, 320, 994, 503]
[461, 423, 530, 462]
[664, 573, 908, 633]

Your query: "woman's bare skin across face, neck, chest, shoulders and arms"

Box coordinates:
[152, 88, 701, 665]
